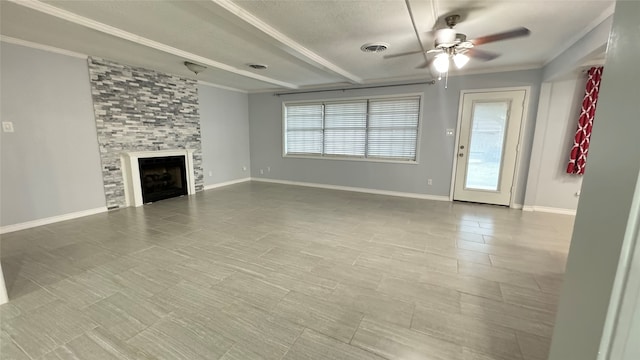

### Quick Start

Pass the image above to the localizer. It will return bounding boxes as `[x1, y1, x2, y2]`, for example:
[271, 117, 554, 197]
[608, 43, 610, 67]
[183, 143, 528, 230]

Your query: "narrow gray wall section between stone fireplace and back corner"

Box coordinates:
[198, 84, 251, 186]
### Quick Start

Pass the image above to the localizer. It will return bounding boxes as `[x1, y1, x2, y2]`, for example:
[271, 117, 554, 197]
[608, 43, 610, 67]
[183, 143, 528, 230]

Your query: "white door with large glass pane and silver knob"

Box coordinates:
[453, 90, 526, 205]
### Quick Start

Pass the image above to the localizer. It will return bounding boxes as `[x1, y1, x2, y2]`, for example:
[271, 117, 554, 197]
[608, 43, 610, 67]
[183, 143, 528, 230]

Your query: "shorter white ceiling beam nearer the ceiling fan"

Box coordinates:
[211, 0, 363, 84]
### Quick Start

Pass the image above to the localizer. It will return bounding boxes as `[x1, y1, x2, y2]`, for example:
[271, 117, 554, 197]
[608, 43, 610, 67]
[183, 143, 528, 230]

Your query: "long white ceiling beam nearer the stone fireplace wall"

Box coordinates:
[8, 0, 299, 89]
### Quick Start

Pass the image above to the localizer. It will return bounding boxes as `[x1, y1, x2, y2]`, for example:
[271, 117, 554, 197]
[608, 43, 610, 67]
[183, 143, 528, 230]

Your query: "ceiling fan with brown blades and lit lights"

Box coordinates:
[384, 14, 531, 73]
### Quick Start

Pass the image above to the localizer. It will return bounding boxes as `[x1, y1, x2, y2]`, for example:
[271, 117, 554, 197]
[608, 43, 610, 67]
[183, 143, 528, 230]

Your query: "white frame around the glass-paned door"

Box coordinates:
[449, 86, 531, 209]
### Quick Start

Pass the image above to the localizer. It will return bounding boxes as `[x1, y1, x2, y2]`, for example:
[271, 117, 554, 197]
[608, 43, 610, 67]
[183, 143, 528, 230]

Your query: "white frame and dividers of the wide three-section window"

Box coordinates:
[281, 92, 424, 165]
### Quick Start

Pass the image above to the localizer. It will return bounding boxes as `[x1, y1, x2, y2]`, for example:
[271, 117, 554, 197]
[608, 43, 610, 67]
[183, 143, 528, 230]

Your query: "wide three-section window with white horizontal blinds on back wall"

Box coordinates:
[284, 96, 420, 161]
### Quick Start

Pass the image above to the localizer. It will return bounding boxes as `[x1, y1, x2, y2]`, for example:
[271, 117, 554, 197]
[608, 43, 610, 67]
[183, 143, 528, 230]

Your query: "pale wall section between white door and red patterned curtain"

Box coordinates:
[525, 9, 613, 210]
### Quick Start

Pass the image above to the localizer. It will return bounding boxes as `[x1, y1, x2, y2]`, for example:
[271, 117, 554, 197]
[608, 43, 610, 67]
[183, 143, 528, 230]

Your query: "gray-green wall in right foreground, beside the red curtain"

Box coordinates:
[549, 1, 640, 360]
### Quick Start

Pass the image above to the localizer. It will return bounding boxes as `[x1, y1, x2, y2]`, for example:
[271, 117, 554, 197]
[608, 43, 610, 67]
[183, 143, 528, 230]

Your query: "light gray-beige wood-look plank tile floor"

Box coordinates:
[0, 182, 573, 360]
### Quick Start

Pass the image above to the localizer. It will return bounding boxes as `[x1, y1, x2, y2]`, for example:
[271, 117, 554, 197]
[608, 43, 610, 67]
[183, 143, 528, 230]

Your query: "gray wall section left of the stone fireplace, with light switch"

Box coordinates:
[0, 42, 105, 226]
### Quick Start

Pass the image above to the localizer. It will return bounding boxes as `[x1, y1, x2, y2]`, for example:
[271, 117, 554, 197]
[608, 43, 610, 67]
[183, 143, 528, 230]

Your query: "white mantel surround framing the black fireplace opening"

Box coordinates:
[120, 149, 196, 207]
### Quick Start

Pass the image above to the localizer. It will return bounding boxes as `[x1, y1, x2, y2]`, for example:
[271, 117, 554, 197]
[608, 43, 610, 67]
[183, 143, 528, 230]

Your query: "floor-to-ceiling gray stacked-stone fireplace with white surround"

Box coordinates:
[88, 57, 204, 209]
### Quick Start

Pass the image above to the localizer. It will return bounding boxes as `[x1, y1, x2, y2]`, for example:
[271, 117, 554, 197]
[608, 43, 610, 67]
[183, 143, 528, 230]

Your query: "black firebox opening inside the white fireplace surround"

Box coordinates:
[138, 156, 188, 204]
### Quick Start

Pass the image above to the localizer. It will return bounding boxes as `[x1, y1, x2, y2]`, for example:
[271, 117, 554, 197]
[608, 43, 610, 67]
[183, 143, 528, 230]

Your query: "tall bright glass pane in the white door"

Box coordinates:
[465, 101, 511, 191]
